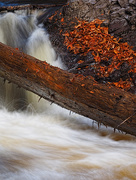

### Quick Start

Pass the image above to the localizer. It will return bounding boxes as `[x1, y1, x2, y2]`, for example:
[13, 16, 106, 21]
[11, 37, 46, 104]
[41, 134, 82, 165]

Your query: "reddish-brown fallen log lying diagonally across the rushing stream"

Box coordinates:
[0, 43, 136, 136]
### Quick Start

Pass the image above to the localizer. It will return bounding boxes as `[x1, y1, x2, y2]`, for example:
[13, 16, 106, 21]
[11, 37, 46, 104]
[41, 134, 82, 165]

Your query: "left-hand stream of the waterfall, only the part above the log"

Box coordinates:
[0, 12, 36, 51]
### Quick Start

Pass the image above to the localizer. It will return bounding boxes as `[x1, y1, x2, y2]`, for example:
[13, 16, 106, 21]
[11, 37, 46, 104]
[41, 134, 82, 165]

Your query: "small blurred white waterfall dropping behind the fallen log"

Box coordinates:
[0, 11, 62, 111]
